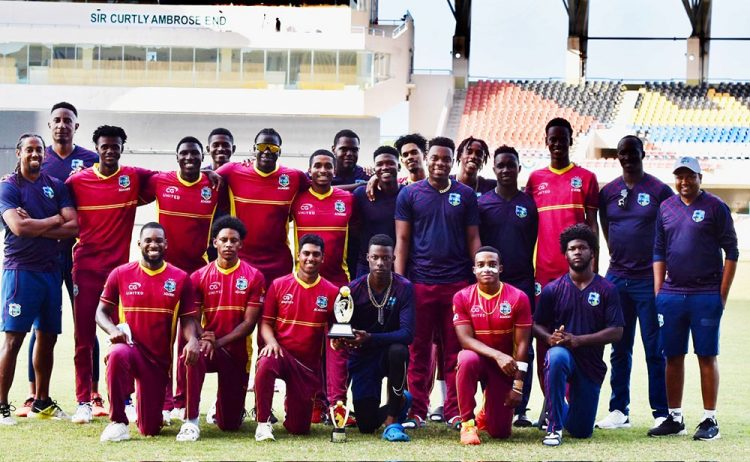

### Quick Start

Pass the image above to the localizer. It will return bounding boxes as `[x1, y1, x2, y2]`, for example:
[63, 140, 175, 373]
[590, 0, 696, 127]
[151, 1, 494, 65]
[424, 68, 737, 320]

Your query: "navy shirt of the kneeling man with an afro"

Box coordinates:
[534, 274, 625, 384]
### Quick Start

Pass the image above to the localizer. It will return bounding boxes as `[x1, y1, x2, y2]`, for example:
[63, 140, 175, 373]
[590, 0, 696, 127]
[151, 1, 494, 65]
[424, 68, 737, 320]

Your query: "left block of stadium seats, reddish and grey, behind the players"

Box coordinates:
[457, 80, 622, 151]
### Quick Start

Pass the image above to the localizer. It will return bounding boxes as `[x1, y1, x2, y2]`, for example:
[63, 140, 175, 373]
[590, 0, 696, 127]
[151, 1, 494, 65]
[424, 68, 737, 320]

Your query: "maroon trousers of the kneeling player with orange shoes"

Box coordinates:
[456, 350, 515, 438]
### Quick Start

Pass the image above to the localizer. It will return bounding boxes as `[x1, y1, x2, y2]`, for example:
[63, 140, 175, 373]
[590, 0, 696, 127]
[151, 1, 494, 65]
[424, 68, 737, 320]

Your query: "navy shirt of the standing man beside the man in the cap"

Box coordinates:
[599, 173, 674, 279]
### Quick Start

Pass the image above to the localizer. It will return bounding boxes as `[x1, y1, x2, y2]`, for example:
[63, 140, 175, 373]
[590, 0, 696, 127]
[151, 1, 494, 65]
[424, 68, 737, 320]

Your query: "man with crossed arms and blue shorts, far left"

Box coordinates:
[0, 134, 78, 425]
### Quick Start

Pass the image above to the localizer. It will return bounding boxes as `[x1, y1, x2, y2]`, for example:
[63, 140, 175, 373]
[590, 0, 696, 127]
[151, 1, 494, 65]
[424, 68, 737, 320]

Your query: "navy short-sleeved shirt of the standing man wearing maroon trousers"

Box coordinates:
[396, 179, 479, 284]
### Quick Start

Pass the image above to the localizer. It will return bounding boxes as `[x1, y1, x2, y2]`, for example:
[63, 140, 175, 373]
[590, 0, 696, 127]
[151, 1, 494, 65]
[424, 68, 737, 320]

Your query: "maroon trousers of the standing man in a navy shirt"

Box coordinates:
[408, 281, 466, 420]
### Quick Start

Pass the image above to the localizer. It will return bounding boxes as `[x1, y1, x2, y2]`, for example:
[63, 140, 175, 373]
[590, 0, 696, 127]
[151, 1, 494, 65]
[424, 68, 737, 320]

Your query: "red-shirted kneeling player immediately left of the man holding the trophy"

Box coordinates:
[255, 234, 338, 441]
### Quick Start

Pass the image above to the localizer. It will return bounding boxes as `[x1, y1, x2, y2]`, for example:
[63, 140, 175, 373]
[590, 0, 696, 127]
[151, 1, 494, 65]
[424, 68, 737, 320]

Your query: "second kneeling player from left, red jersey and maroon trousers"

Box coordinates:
[177, 216, 265, 441]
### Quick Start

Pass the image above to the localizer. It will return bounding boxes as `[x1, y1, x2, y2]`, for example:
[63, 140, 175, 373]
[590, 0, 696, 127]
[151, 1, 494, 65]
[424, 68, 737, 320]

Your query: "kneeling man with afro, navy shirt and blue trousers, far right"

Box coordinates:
[534, 223, 624, 446]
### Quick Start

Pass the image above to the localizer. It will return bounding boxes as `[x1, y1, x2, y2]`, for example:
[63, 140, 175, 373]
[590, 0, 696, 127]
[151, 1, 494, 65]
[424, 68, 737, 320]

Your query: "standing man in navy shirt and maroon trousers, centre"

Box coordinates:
[395, 137, 480, 427]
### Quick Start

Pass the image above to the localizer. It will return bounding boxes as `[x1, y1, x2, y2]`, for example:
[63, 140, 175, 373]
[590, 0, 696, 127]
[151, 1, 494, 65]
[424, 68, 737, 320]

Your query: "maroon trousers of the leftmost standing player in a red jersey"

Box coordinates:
[73, 268, 108, 403]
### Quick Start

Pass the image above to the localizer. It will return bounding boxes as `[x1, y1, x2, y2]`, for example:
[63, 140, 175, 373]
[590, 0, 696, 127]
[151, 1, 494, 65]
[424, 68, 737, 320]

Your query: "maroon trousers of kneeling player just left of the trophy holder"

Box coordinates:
[255, 348, 321, 435]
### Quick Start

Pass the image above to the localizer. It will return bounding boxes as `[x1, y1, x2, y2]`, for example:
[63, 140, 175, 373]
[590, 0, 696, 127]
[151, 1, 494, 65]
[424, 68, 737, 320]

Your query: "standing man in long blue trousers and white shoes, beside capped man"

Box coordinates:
[596, 135, 674, 429]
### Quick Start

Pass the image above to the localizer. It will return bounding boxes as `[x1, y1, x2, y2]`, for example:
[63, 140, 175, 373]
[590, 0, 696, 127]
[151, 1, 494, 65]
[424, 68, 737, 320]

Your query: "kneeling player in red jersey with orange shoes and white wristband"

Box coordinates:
[453, 247, 531, 444]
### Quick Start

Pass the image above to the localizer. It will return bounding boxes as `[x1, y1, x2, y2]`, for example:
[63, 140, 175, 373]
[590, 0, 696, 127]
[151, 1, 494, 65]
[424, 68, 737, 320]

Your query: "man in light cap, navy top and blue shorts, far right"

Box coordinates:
[648, 157, 739, 441]
